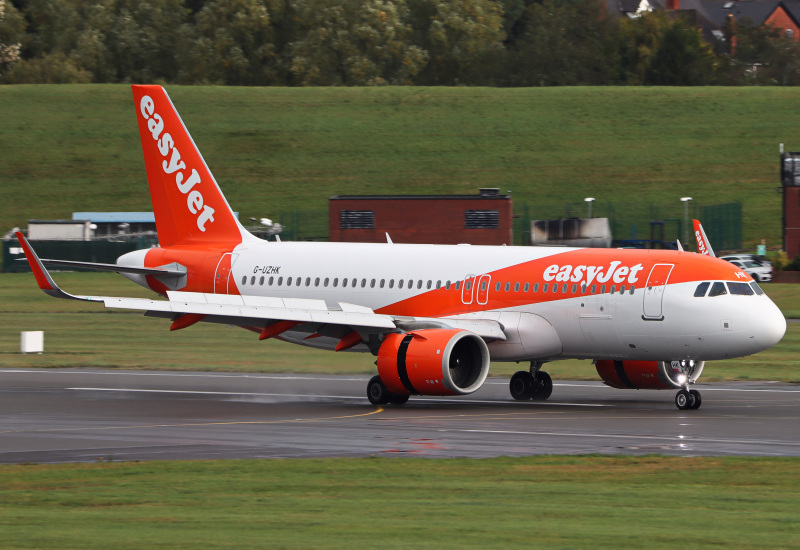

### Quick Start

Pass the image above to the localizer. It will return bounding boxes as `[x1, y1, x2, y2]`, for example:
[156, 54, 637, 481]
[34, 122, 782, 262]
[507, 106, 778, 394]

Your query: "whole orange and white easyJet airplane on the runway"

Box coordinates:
[17, 86, 786, 410]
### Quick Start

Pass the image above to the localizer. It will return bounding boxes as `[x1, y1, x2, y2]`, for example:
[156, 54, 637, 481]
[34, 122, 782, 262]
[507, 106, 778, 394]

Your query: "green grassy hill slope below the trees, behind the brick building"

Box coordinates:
[0, 85, 800, 246]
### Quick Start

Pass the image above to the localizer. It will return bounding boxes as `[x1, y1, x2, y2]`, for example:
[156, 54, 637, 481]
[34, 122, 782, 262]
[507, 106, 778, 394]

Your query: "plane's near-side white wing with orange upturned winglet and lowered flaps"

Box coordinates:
[17, 233, 506, 340]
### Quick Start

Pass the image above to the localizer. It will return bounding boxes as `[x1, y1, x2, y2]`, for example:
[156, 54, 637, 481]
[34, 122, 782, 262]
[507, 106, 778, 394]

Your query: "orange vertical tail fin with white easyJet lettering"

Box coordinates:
[132, 86, 249, 246]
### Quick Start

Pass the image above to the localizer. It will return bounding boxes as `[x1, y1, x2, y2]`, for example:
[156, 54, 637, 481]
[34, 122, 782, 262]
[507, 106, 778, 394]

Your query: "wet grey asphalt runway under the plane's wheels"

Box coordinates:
[0, 369, 800, 463]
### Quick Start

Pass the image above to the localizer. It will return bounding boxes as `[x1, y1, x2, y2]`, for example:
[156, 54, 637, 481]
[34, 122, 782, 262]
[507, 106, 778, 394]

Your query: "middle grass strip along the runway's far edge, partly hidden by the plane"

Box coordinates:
[0, 273, 800, 383]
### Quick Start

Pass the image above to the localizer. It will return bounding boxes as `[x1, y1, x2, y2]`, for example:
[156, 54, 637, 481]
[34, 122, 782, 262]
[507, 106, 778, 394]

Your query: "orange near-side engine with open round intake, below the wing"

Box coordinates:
[378, 329, 489, 395]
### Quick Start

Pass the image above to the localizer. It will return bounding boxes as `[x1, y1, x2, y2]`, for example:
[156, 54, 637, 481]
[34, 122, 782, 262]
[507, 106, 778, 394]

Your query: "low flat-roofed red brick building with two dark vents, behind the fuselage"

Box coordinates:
[328, 189, 513, 245]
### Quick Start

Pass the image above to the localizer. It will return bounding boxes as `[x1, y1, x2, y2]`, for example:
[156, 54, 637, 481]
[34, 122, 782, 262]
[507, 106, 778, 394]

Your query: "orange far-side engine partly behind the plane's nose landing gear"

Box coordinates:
[595, 359, 705, 390]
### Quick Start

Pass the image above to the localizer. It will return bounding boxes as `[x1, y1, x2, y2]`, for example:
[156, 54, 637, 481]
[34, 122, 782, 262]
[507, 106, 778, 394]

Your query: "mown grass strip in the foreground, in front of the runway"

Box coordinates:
[0, 456, 800, 550]
